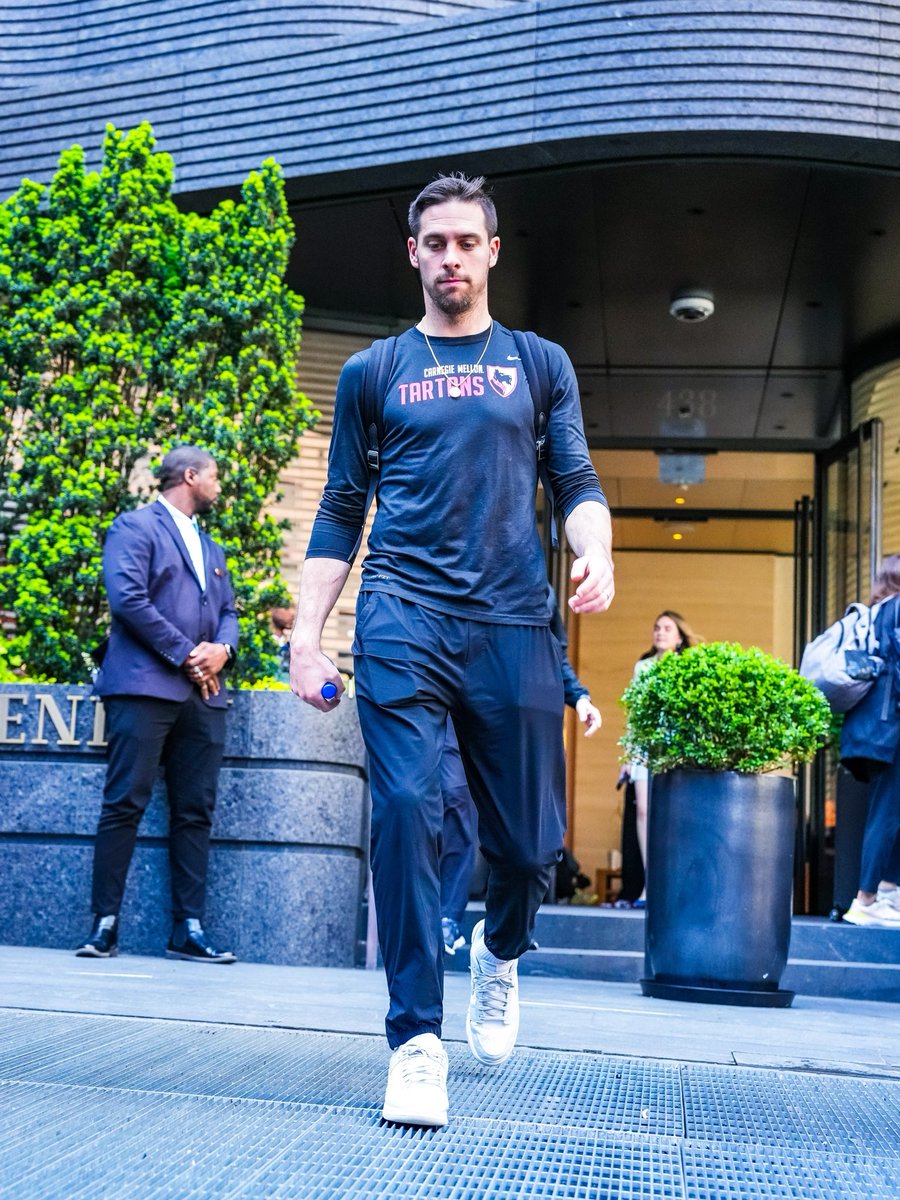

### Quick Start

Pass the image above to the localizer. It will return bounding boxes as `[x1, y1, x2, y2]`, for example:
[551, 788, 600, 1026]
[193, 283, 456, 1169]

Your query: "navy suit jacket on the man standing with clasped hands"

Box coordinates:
[94, 503, 238, 708]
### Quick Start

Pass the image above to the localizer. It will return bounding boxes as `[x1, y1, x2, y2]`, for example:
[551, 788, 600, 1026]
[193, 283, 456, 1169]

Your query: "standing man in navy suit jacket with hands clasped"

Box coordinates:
[76, 445, 238, 962]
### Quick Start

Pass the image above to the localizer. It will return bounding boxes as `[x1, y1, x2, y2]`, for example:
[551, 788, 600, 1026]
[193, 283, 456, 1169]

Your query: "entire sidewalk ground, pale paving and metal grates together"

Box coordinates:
[0, 947, 900, 1200]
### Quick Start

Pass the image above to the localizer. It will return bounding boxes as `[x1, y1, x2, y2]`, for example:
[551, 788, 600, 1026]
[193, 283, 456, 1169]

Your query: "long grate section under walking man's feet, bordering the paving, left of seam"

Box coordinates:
[0, 1014, 683, 1135]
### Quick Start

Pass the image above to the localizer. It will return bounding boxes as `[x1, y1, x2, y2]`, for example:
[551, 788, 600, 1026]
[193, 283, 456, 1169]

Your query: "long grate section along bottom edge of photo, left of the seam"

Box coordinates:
[0, 1084, 684, 1200]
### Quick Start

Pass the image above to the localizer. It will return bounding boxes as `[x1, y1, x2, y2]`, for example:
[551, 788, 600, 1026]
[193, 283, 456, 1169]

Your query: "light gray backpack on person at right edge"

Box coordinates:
[800, 604, 884, 713]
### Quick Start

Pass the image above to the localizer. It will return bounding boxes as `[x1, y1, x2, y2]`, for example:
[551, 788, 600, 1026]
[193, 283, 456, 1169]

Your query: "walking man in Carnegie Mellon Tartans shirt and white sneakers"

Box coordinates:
[290, 174, 613, 1126]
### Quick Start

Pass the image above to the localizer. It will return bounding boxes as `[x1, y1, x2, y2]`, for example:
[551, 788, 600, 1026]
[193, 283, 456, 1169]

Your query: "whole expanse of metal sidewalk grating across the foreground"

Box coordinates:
[0, 1010, 900, 1200]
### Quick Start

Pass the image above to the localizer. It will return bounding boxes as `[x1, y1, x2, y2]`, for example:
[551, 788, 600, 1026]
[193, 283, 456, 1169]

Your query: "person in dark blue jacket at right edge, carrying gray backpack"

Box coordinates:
[841, 554, 900, 930]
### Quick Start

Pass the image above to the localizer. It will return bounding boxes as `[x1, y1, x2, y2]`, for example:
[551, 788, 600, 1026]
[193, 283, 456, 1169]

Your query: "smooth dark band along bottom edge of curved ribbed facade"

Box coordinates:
[176, 130, 900, 212]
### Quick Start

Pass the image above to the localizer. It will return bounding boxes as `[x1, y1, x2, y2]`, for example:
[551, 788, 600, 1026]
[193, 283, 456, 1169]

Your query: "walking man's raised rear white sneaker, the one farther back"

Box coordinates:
[466, 913, 520, 1067]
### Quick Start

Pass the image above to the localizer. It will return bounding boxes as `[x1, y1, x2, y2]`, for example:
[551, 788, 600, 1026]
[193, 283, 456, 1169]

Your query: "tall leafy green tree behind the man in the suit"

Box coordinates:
[0, 124, 316, 680]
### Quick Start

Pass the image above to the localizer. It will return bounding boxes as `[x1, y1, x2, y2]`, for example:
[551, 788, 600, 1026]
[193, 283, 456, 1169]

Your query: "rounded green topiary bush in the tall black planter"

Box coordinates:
[619, 642, 830, 774]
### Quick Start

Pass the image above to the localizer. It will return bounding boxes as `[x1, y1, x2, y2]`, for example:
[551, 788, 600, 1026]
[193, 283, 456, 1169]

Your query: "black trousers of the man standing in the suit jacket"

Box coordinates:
[91, 692, 226, 920]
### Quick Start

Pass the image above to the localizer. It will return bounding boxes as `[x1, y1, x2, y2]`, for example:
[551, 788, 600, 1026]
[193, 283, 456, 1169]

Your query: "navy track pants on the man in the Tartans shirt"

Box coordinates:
[354, 592, 565, 1049]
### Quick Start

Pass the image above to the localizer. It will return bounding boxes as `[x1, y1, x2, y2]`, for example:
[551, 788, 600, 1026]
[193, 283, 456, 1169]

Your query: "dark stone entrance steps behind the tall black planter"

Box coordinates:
[444, 902, 900, 1002]
